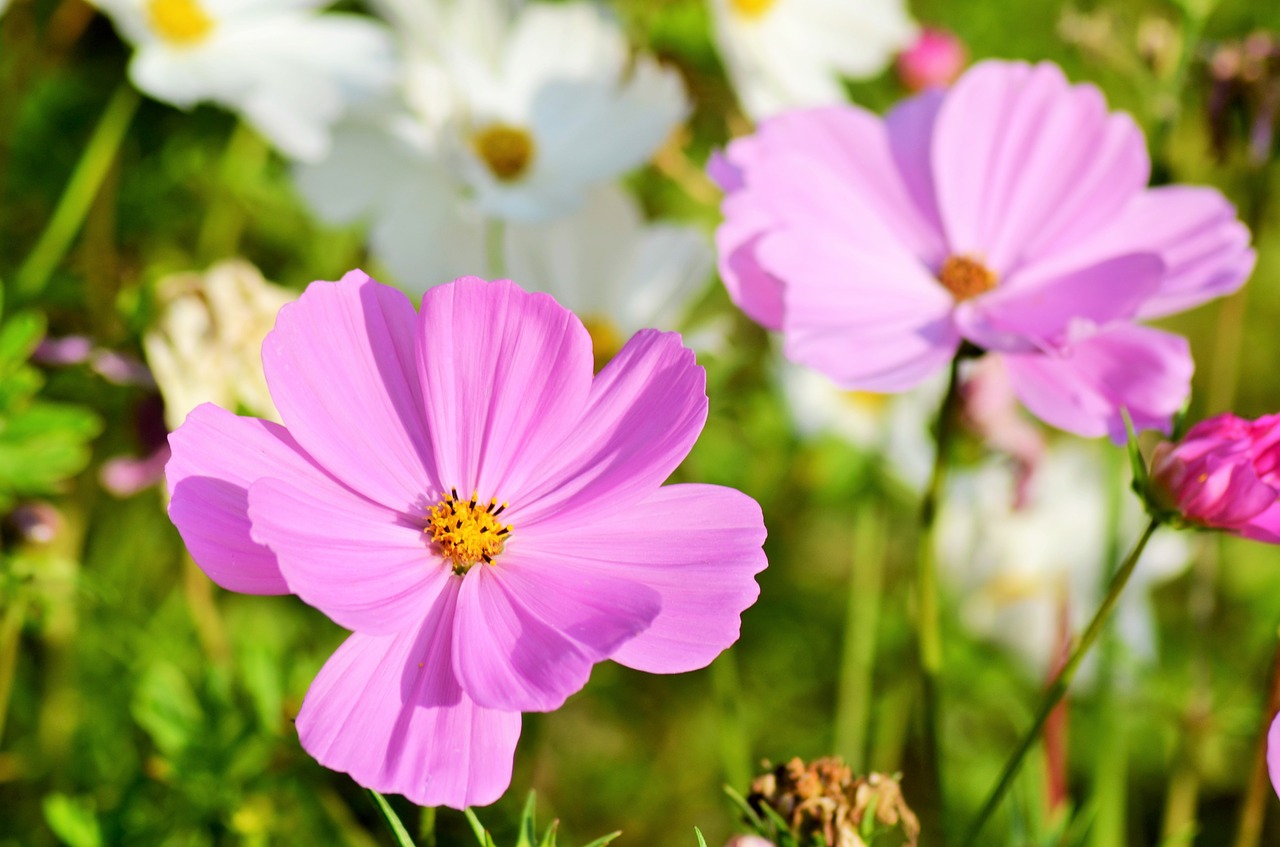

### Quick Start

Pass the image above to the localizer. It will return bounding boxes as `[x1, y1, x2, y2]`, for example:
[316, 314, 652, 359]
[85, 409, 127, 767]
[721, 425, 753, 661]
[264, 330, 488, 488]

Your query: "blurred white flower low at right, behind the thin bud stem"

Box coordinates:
[937, 443, 1190, 678]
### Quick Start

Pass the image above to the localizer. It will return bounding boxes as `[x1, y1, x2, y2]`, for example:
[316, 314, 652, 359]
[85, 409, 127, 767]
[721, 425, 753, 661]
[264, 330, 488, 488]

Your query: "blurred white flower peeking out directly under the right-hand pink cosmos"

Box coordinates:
[778, 361, 946, 493]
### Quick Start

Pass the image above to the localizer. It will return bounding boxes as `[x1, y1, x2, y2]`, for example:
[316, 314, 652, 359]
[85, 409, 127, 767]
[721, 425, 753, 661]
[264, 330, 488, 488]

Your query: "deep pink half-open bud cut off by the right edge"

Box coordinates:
[1151, 415, 1280, 544]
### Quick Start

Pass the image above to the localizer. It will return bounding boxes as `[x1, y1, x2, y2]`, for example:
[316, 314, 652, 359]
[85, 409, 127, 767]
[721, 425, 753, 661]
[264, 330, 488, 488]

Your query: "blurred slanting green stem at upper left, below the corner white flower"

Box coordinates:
[14, 82, 140, 299]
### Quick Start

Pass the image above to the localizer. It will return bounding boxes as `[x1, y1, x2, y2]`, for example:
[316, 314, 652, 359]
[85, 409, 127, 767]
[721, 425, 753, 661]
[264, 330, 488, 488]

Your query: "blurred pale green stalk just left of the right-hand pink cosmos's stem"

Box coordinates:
[836, 505, 884, 773]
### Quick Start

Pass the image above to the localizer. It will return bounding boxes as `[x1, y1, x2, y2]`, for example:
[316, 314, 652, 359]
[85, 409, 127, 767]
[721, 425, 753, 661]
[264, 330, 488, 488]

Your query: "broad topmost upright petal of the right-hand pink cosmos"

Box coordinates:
[933, 61, 1149, 276]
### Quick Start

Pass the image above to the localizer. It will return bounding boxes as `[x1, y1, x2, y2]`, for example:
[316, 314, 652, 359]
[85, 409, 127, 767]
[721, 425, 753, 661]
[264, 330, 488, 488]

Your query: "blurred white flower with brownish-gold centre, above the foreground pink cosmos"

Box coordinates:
[296, 0, 689, 281]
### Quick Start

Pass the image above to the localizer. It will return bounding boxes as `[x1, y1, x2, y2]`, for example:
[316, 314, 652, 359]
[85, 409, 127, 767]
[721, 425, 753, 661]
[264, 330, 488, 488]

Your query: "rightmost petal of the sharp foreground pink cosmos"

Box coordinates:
[527, 485, 767, 673]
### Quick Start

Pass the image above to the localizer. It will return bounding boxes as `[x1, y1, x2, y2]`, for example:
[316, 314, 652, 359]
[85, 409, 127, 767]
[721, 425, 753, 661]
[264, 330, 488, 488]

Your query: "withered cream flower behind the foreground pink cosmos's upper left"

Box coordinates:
[142, 260, 297, 430]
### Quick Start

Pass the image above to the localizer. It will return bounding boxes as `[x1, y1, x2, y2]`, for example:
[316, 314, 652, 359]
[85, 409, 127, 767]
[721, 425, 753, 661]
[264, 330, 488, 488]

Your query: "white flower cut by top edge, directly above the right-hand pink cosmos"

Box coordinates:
[709, 0, 916, 120]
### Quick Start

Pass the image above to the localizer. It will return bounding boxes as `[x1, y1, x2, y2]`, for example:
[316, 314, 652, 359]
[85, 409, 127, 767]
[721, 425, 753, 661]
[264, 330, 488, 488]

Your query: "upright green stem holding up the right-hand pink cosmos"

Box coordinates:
[915, 354, 963, 816]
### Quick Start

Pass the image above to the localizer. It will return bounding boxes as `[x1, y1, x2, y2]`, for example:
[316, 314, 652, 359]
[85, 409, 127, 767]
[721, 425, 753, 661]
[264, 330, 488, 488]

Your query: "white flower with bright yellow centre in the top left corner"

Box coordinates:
[93, 0, 396, 160]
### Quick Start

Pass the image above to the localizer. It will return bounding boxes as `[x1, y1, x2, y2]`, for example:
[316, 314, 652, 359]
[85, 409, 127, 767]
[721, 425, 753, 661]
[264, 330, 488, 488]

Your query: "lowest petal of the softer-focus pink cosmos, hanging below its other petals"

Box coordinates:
[1005, 325, 1193, 444]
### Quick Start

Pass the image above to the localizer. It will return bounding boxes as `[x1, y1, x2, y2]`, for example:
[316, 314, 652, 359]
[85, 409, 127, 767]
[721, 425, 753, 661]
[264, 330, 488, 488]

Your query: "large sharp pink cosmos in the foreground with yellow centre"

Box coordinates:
[158, 271, 765, 807]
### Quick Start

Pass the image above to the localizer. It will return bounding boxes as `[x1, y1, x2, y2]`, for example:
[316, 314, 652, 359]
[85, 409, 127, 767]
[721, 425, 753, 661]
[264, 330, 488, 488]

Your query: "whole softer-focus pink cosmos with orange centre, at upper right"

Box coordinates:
[710, 61, 1254, 440]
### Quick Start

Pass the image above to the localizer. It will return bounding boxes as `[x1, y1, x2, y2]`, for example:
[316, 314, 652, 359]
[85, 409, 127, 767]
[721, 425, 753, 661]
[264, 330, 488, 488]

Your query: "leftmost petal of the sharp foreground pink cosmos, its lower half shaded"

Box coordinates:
[165, 403, 326, 594]
